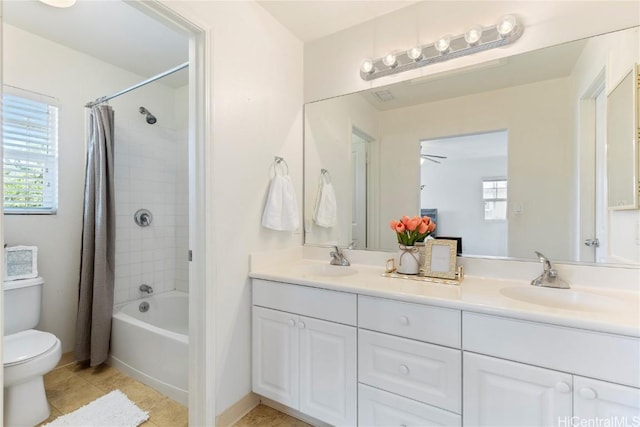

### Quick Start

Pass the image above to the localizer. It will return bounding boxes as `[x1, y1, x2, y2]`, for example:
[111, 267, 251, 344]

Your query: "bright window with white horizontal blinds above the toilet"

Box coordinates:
[2, 87, 58, 214]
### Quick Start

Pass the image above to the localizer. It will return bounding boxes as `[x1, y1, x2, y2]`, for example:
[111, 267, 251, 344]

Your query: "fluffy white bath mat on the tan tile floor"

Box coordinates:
[44, 390, 149, 427]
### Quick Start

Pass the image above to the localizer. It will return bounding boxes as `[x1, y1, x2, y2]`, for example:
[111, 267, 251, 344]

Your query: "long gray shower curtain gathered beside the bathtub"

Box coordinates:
[75, 105, 115, 366]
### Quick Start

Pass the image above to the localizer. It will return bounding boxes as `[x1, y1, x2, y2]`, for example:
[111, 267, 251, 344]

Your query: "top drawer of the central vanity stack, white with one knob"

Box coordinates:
[358, 296, 461, 348]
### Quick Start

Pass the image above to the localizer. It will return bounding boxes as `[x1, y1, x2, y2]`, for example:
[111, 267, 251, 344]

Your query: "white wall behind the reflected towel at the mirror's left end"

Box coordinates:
[304, 96, 378, 246]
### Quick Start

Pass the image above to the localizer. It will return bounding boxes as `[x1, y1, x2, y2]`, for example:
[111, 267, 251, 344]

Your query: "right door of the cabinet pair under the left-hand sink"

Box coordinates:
[298, 316, 357, 426]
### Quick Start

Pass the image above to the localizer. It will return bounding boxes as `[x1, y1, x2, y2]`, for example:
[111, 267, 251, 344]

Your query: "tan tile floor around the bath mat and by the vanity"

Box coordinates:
[40, 353, 311, 427]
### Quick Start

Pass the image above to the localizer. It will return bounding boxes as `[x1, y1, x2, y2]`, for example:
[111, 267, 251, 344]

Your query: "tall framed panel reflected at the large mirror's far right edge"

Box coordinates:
[607, 66, 639, 209]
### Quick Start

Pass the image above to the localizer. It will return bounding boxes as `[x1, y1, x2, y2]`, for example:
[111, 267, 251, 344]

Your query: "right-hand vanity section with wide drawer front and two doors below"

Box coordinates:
[463, 312, 640, 426]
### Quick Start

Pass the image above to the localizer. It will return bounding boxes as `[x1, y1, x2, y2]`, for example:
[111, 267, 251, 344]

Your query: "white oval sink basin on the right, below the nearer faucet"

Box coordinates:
[500, 286, 624, 311]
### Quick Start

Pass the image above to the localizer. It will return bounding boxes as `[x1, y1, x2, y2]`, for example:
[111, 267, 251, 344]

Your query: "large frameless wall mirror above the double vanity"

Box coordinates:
[304, 27, 640, 265]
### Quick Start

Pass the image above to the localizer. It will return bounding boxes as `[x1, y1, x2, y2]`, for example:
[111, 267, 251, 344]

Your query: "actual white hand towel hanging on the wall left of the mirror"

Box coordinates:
[262, 174, 300, 231]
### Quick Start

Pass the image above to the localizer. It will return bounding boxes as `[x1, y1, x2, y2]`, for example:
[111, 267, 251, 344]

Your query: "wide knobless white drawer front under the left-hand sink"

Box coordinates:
[253, 279, 357, 326]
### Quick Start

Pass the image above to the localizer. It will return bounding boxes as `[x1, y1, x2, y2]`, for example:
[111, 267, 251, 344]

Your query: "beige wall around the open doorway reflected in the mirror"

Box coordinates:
[372, 79, 573, 260]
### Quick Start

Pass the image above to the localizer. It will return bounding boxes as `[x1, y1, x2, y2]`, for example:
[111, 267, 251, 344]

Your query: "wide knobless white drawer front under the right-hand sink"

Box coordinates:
[462, 312, 640, 387]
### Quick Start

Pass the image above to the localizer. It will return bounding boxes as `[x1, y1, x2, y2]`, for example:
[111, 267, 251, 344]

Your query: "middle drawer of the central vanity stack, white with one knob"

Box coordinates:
[358, 330, 461, 413]
